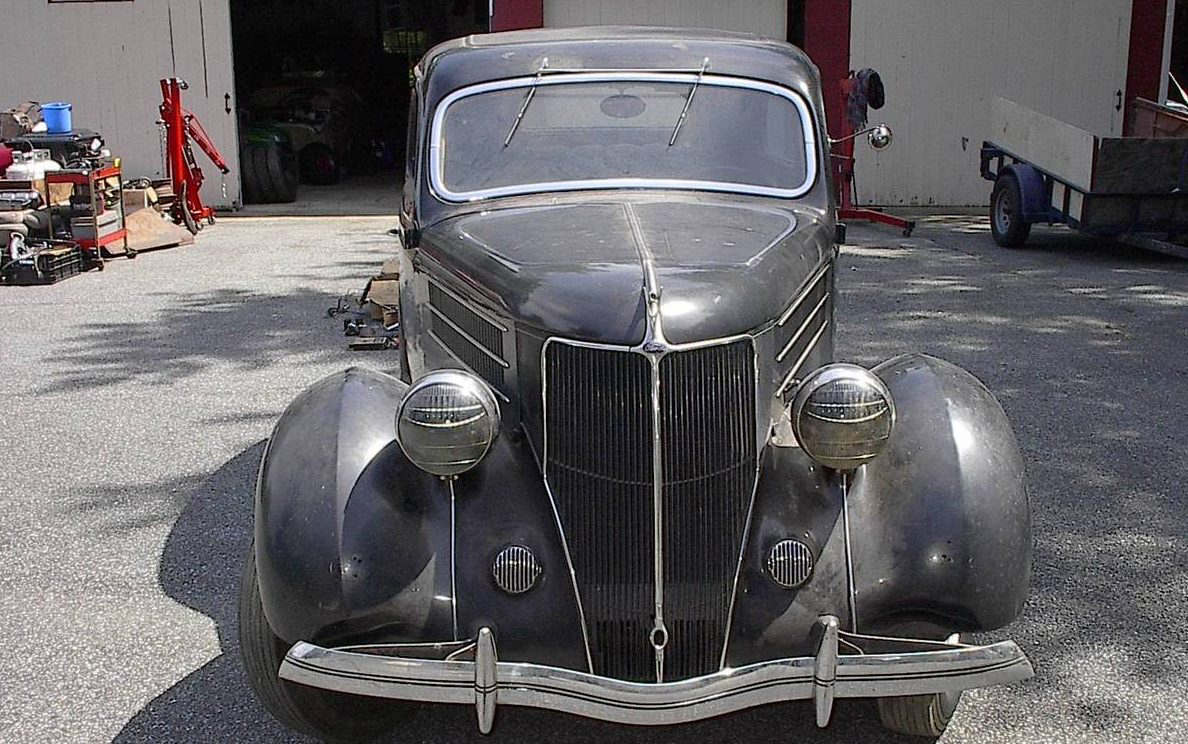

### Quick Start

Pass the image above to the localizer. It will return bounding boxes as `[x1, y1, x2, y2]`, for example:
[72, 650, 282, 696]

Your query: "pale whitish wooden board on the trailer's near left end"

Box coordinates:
[990, 97, 1098, 191]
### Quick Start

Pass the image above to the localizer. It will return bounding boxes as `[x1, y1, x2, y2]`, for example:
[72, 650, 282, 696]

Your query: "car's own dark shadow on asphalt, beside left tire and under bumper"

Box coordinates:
[114, 442, 918, 744]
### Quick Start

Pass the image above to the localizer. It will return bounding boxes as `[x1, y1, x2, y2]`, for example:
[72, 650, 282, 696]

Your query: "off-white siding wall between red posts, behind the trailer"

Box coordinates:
[849, 0, 1131, 206]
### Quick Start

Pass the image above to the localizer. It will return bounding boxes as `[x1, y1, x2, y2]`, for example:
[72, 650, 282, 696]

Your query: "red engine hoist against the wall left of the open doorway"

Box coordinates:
[159, 77, 230, 233]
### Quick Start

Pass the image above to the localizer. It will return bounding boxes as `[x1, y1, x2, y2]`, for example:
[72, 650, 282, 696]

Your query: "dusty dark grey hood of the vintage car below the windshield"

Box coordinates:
[421, 200, 833, 345]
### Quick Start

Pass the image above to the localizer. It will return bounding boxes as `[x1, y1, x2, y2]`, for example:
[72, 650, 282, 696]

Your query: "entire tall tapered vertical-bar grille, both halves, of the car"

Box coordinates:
[544, 340, 757, 681]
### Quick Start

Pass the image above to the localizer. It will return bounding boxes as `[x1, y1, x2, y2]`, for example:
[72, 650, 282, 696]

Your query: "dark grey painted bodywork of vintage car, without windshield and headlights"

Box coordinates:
[255, 29, 1031, 674]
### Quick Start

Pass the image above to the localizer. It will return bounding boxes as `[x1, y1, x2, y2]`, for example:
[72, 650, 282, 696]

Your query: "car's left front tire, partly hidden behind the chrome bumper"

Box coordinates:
[239, 546, 406, 742]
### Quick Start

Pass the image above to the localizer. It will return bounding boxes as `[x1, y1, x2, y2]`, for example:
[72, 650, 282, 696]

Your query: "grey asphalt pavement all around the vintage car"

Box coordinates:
[0, 215, 1188, 744]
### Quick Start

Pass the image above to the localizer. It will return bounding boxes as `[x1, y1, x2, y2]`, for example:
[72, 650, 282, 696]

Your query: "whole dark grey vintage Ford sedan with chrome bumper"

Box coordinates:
[240, 27, 1032, 739]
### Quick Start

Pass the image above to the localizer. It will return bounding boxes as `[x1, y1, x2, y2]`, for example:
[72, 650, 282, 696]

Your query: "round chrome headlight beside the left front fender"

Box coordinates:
[396, 370, 499, 477]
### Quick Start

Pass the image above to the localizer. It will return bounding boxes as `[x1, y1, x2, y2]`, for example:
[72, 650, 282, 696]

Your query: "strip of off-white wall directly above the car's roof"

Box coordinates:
[544, 0, 788, 39]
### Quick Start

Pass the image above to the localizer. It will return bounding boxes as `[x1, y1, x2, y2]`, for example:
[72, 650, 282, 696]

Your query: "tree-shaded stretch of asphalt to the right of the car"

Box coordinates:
[838, 229, 1188, 740]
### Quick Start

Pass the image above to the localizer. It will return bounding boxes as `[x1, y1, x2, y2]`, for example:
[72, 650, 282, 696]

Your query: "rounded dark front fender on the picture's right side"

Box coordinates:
[847, 354, 1031, 632]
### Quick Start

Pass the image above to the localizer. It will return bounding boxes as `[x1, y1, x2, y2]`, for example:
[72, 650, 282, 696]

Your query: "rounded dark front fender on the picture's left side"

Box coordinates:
[255, 367, 453, 642]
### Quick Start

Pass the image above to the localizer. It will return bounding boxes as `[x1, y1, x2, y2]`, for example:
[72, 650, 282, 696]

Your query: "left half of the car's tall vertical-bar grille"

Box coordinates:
[545, 343, 655, 680]
